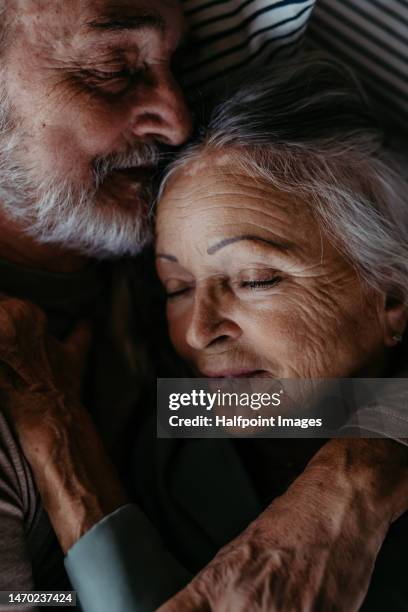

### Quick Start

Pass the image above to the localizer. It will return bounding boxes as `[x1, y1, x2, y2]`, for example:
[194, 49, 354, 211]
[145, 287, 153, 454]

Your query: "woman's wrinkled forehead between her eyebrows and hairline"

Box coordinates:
[159, 158, 332, 267]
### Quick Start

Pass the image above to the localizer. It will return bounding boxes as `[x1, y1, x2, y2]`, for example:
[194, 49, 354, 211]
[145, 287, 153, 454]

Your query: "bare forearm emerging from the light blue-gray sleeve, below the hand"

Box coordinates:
[17, 399, 127, 552]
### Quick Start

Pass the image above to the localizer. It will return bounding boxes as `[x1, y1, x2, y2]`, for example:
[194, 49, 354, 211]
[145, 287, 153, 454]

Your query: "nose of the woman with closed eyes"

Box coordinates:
[186, 290, 242, 350]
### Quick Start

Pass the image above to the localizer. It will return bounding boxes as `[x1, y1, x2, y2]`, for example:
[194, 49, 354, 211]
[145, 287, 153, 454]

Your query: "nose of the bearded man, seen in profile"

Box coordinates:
[132, 69, 192, 146]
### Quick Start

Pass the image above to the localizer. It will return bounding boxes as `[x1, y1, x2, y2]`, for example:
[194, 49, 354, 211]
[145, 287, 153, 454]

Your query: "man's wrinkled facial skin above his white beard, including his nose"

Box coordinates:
[5, 0, 191, 184]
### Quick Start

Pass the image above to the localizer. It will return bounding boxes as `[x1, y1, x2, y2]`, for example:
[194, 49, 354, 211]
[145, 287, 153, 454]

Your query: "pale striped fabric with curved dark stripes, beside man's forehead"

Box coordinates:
[182, 0, 314, 88]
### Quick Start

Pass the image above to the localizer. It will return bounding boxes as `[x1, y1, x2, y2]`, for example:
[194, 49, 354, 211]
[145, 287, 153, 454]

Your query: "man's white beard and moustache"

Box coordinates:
[0, 94, 158, 258]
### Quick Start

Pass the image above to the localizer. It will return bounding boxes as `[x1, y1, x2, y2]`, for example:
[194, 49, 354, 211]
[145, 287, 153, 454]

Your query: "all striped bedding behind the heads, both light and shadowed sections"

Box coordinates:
[182, 0, 408, 132]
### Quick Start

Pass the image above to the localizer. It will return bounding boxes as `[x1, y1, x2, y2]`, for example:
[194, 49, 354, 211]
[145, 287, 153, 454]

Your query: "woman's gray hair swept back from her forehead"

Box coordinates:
[159, 56, 408, 304]
